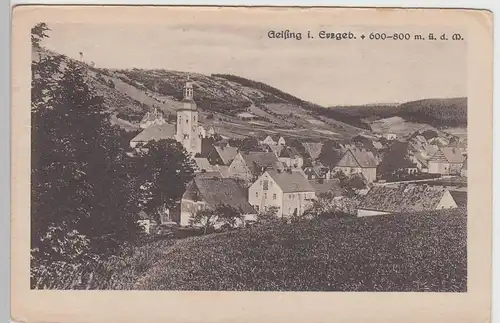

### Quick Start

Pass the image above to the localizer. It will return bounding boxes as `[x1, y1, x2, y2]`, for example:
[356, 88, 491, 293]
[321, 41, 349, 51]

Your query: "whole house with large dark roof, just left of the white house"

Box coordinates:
[179, 176, 256, 226]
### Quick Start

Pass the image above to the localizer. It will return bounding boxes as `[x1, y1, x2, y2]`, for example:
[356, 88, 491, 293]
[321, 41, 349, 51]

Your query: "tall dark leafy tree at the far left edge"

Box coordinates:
[31, 24, 143, 268]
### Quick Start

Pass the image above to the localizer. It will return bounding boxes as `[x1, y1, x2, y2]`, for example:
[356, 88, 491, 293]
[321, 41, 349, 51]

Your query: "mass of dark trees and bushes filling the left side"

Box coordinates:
[31, 23, 194, 288]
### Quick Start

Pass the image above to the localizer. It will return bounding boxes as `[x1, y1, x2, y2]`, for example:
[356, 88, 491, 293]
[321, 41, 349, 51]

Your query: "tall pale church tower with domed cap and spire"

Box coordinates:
[175, 80, 201, 155]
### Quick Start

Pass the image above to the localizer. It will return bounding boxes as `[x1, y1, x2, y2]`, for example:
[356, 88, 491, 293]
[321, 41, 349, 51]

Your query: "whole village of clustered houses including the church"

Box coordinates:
[130, 82, 467, 226]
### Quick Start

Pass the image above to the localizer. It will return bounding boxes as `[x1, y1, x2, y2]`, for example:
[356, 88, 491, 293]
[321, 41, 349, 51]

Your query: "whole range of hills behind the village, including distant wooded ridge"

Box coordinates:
[33, 49, 467, 140]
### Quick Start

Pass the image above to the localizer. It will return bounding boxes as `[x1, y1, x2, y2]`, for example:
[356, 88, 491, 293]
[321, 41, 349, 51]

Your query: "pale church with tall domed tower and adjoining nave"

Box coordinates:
[130, 80, 204, 156]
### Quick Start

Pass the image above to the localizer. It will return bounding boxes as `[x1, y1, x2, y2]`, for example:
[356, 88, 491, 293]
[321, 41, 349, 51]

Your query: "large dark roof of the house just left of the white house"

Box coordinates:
[182, 177, 255, 214]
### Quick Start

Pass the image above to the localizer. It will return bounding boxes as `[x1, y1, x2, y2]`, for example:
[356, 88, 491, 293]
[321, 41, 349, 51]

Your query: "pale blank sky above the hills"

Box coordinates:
[44, 21, 467, 106]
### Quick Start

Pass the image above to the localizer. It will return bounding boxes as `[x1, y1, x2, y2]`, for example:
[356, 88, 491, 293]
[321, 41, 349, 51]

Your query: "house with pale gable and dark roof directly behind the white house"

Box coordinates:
[228, 151, 284, 184]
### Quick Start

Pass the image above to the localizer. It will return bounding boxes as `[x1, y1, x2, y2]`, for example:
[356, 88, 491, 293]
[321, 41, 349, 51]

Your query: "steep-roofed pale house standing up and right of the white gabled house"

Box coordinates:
[333, 149, 378, 183]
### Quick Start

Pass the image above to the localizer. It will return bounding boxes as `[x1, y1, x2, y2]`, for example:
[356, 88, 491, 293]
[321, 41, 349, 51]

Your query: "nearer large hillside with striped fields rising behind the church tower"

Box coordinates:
[34, 50, 363, 140]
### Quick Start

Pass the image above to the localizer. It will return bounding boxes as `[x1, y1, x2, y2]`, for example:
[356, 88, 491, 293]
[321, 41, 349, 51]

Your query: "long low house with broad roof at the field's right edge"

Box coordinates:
[357, 185, 457, 217]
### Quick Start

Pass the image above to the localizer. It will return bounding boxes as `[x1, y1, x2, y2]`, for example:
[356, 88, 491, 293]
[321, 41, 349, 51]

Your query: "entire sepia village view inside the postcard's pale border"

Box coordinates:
[31, 14, 467, 292]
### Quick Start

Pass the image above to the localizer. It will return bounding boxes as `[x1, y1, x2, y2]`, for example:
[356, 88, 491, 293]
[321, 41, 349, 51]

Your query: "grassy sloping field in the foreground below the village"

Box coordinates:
[88, 209, 467, 292]
